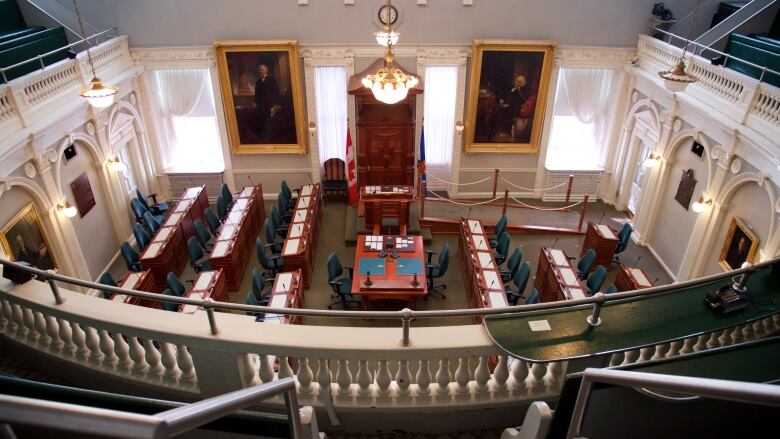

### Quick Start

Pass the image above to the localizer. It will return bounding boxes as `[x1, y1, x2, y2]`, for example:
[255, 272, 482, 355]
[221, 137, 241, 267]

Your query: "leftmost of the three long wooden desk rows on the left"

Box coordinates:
[141, 186, 208, 292]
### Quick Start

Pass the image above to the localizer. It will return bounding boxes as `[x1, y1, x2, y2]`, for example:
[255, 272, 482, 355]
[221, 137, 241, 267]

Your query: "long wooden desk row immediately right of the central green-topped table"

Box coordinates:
[458, 218, 509, 323]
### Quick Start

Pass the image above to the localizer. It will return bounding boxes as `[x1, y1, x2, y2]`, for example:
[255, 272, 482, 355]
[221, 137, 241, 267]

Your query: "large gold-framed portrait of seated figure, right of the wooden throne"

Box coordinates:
[465, 40, 555, 153]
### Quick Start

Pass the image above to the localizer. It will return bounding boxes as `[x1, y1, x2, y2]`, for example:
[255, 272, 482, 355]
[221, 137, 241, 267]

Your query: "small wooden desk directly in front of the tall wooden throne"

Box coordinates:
[360, 186, 414, 235]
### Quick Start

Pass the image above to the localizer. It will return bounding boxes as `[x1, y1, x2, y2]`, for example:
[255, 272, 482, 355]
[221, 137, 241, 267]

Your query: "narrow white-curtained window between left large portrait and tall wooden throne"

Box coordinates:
[314, 66, 354, 164]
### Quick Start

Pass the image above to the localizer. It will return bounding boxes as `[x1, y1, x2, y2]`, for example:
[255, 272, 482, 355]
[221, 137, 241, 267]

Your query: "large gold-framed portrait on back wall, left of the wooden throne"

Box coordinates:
[214, 41, 306, 154]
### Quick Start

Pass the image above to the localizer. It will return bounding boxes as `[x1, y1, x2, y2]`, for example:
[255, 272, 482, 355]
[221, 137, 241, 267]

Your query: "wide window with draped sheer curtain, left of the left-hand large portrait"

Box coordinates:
[150, 69, 224, 172]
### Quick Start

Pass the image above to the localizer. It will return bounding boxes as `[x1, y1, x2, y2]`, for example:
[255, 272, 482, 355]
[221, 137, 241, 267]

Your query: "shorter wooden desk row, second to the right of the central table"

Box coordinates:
[534, 247, 587, 302]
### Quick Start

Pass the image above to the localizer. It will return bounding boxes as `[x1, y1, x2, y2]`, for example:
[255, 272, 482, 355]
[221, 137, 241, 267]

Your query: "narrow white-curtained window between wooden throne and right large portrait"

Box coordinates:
[423, 65, 458, 189]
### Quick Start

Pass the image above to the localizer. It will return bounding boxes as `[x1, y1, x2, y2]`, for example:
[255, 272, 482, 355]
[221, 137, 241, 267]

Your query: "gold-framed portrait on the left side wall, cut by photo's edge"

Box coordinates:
[0, 203, 57, 270]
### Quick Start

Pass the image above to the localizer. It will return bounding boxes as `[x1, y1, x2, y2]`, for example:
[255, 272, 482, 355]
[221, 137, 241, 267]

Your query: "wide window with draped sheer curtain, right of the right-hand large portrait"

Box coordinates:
[545, 69, 618, 170]
